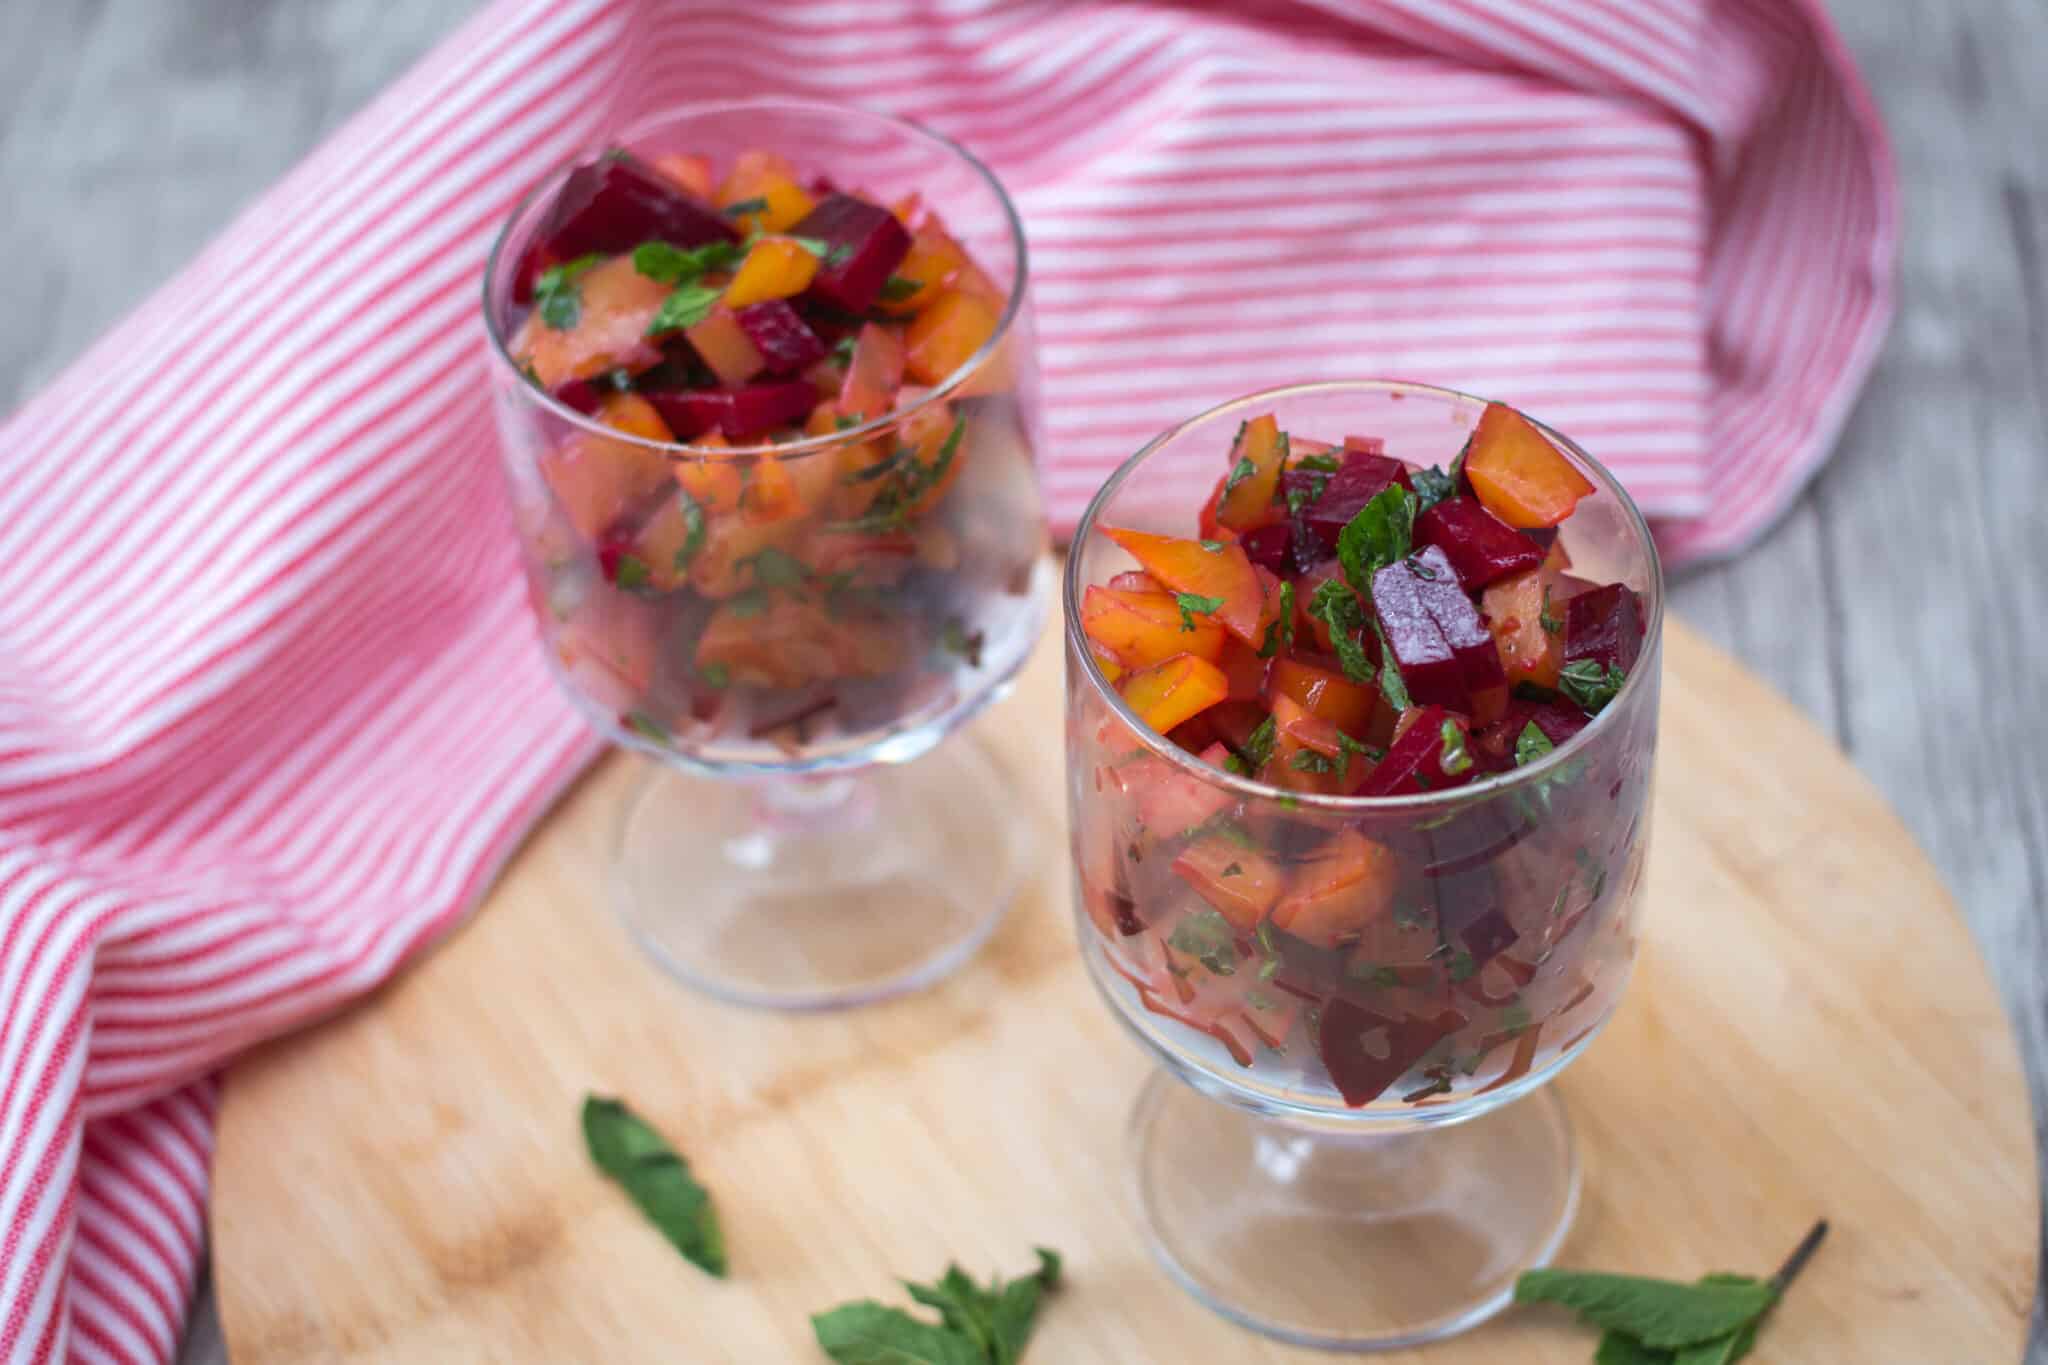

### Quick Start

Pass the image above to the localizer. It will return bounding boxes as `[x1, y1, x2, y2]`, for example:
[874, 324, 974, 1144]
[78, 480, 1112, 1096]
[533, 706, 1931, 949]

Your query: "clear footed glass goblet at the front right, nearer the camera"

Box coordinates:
[1065, 381, 1663, 1349]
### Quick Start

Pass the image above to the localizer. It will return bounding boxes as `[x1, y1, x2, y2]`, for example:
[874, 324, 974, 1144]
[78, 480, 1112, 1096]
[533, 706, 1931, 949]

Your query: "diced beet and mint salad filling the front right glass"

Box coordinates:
[1069, 403, 1655, 1107]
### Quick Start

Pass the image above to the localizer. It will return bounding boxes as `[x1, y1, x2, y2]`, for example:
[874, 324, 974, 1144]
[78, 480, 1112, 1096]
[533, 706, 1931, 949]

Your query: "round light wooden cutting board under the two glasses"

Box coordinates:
[213, 601, 2038, 1365]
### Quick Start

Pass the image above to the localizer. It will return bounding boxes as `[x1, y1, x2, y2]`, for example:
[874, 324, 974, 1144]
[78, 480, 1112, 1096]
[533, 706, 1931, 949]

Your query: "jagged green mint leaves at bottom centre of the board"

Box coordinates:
[811, 1246, 1061, 1365]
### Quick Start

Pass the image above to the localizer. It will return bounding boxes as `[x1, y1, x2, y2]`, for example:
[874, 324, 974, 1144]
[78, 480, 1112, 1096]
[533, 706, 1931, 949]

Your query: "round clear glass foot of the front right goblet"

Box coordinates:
[1130, 1072, 1579, 1351]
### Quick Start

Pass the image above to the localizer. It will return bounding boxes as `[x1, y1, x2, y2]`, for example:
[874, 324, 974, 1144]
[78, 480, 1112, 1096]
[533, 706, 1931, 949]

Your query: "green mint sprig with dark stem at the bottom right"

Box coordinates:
[1516, 1220, 1827, 1365]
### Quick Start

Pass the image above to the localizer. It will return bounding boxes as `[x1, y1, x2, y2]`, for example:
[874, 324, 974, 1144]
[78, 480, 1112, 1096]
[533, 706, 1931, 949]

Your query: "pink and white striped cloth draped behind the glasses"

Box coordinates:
[0, 0, 1896, 1361]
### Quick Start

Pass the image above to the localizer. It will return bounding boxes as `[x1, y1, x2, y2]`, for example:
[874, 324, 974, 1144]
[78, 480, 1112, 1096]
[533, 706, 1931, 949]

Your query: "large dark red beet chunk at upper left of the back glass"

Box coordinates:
[512, 151, 739, 303]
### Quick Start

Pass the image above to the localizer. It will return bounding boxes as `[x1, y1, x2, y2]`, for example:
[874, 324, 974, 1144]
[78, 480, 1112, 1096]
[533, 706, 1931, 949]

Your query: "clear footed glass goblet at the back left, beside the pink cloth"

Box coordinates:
[483, 98, 1053, 1009]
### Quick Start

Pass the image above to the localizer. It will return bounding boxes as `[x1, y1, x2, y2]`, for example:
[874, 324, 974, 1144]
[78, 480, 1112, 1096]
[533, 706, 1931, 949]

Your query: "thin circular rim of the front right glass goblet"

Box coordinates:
[1061, 379, 1665, 812]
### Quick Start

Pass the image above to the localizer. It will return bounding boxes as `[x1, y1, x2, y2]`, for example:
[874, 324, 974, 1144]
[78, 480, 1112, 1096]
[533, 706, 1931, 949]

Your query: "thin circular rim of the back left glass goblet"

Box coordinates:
[483, 96, 1030, 460]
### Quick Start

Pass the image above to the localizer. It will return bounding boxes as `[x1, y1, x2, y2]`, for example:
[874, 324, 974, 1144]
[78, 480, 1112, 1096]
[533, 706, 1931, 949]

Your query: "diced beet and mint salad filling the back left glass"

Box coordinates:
[487, 149, 1044, 763]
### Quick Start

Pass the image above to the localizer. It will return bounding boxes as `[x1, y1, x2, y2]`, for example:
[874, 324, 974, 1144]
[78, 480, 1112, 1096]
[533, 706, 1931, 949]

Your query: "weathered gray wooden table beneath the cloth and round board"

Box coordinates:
[0, 0, 2048, 1365]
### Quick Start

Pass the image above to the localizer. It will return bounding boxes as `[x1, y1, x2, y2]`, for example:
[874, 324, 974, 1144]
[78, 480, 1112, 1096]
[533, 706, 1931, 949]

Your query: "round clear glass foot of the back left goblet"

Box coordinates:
[612, 735, 1030, 1009]
